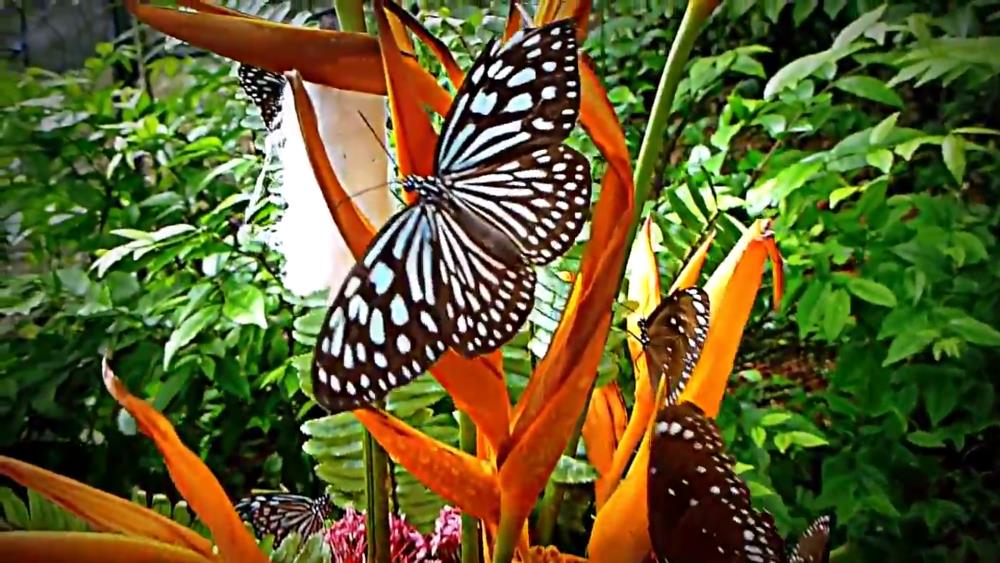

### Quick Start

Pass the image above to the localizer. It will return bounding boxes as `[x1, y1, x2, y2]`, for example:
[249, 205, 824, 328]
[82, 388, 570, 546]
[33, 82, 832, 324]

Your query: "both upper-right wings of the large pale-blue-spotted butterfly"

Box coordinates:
[435, 20, 591, 264]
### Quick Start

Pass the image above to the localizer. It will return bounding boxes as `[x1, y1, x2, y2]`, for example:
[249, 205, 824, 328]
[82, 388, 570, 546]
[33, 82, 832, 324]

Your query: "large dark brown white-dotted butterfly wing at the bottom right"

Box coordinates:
[646, 401, 785, 563]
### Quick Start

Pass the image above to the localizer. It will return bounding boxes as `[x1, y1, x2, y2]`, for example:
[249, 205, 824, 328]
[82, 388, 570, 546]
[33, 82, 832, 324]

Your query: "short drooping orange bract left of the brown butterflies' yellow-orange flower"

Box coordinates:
[582, 382, 628, 508]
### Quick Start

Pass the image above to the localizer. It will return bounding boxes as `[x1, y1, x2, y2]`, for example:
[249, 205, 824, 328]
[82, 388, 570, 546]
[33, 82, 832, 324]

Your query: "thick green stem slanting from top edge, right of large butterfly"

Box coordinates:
[626, 0, 718, 251]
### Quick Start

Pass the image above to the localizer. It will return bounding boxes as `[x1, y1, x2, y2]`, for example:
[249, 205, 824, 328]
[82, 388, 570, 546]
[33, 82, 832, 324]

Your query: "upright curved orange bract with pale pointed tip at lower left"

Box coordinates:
[104, 361, 267, 562]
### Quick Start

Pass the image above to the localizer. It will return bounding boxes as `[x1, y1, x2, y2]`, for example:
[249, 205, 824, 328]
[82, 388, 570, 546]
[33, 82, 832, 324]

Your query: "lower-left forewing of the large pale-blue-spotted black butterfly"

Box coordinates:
[312, 202, 454, 413]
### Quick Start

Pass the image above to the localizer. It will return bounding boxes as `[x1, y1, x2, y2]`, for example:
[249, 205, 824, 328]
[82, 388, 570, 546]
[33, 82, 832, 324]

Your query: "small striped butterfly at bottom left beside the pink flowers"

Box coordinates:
[235, 493, 333, 546]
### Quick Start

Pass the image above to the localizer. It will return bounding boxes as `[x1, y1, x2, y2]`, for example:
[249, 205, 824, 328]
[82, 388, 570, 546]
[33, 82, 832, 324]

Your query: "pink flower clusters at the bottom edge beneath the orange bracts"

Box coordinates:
[326, 506, 462, 563]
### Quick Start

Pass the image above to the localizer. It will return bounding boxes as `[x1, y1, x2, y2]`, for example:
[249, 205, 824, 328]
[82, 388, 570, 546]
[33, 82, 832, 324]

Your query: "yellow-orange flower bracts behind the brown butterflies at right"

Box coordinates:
[588, 220, 782, 562]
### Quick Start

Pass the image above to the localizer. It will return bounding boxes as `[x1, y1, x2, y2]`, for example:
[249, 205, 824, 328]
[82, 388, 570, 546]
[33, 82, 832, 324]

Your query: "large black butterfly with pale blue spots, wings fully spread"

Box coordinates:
[312, 20, 591, 412]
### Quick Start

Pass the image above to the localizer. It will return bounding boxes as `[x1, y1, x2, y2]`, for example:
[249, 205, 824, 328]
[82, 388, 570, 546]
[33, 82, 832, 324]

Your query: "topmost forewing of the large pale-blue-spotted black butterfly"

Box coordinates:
[434, 20, 580, 179]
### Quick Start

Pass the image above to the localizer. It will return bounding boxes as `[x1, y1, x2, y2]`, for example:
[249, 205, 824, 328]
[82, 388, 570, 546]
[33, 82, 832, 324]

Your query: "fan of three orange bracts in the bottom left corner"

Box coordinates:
[0, 363, 267, 562]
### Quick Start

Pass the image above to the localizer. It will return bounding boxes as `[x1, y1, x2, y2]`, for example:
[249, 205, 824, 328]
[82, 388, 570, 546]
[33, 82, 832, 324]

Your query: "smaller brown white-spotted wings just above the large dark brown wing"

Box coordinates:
[644, 287, 709, 403]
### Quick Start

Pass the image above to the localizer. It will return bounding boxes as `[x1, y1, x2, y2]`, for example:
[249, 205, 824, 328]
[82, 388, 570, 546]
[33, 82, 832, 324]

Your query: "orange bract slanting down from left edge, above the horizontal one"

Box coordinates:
[0, 456, 214, 561]
